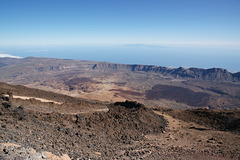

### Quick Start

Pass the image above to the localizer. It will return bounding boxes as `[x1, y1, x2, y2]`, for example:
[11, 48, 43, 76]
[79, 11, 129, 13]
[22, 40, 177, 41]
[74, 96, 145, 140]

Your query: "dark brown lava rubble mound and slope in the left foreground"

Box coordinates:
[0, 92, 166, 159]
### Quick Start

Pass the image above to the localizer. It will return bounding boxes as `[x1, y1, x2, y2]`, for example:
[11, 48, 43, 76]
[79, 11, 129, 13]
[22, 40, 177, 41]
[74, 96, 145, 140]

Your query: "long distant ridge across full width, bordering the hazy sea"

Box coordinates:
[0, 57, 240, 82]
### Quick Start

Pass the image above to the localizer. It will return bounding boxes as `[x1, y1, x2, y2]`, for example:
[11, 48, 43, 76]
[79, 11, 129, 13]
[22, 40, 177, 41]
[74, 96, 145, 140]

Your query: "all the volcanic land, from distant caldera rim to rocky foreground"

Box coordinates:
[0, 57, 240, 160]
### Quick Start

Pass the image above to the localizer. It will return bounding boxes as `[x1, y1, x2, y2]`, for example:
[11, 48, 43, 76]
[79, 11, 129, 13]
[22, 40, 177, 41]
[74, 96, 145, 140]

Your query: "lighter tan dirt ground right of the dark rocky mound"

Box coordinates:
[146, 111, 240, 158]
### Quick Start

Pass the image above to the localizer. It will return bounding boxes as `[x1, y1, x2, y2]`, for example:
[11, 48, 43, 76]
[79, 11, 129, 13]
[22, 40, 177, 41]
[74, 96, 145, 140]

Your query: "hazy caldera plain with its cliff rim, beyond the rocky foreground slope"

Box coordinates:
[0, 57, 240, 109]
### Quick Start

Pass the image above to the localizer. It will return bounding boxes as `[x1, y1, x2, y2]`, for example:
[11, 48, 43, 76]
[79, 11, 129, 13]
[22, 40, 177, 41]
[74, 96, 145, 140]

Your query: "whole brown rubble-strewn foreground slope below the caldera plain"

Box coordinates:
[0, 85, 240, 159]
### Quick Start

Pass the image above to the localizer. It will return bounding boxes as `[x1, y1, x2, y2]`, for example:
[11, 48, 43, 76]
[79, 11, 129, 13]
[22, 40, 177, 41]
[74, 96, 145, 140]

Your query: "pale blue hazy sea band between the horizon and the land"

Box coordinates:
[0, 44, 240, 72]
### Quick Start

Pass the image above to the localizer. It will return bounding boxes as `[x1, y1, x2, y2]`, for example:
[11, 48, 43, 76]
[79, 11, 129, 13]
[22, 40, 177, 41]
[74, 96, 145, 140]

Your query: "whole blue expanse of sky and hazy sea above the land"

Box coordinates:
[0, 0, 240, 71]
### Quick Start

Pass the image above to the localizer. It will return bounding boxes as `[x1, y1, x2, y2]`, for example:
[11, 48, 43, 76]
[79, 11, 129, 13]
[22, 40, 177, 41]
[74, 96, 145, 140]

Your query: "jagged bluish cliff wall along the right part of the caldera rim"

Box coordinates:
[92, 63, 240, 82]
